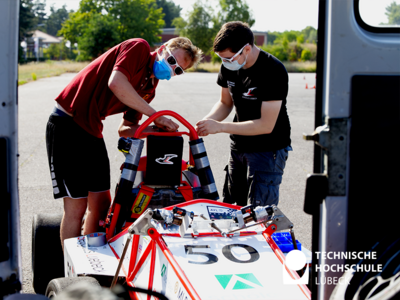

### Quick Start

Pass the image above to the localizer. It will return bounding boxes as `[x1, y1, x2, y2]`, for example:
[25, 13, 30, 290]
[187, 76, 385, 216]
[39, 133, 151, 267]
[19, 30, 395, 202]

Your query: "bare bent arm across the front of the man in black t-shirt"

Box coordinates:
[197, 100, 282, 136]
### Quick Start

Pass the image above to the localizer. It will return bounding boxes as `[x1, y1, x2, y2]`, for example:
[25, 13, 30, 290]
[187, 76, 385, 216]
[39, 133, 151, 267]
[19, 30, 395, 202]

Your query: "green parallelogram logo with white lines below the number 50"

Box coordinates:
[215, 273, 262, 290]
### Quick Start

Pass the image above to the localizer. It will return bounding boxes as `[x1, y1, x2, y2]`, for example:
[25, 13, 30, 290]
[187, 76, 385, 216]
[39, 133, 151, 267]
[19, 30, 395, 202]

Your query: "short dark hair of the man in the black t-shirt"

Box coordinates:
[213, 21, 254, 53]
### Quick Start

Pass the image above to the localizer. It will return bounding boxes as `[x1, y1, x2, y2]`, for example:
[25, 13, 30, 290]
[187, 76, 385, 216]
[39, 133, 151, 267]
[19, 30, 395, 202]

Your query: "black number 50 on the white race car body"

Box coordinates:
[185, 244, 260, 265]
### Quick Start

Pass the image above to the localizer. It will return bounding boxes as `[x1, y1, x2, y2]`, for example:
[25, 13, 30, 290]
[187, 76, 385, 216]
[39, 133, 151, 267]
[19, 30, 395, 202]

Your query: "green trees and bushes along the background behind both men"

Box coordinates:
[19, 0, 400, 62]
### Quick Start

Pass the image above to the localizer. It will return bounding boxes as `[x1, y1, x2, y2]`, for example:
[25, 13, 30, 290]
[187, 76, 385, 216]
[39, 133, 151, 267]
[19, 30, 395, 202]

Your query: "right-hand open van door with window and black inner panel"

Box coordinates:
[304, 0, 400, 299]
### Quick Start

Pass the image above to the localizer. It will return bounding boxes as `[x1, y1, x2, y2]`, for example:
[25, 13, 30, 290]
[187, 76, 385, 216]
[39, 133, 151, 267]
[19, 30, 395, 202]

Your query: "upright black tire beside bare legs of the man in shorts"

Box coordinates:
[32, 214, 64, 294]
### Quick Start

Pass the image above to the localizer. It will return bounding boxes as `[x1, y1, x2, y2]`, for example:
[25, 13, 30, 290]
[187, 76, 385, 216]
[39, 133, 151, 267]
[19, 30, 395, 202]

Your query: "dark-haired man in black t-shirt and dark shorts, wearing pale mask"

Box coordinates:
[196, 22, 292, 206]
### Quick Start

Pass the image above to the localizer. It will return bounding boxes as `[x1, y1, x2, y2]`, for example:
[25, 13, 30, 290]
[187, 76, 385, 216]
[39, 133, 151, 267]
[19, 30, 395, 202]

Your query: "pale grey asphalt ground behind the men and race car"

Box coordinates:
[18, 73, 315, 293]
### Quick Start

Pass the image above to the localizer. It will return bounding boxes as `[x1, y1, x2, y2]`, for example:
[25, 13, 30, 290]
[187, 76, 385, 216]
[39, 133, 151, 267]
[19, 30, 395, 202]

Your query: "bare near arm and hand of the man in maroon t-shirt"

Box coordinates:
[108, 71, 179, 131]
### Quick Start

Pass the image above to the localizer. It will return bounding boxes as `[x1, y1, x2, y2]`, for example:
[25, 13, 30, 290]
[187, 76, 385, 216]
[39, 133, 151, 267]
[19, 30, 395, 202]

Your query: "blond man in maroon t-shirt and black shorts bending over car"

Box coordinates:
[46, 37, 202, 246]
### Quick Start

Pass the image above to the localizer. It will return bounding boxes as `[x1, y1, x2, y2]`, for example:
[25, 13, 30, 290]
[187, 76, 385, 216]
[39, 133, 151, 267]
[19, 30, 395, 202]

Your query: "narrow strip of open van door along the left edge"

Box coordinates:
[0, 0, 22, 299]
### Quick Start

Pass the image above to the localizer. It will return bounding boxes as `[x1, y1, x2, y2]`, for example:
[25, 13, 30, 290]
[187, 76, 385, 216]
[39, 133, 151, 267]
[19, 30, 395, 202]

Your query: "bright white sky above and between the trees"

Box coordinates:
[46, 0, 400, 32]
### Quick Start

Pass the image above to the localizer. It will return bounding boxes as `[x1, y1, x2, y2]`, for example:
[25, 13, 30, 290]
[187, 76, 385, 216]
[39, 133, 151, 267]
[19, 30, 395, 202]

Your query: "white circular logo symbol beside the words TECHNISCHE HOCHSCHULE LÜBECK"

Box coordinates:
[282, 250, 309, 284]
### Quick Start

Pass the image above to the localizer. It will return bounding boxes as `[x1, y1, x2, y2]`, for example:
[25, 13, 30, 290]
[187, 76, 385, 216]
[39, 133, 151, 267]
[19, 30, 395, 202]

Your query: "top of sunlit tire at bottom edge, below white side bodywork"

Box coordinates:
[45, 277, 101, 299]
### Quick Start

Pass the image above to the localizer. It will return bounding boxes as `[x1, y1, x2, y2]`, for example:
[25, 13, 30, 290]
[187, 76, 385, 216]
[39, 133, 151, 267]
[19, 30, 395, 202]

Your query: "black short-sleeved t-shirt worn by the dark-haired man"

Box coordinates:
[217, 50, 291, 152]
